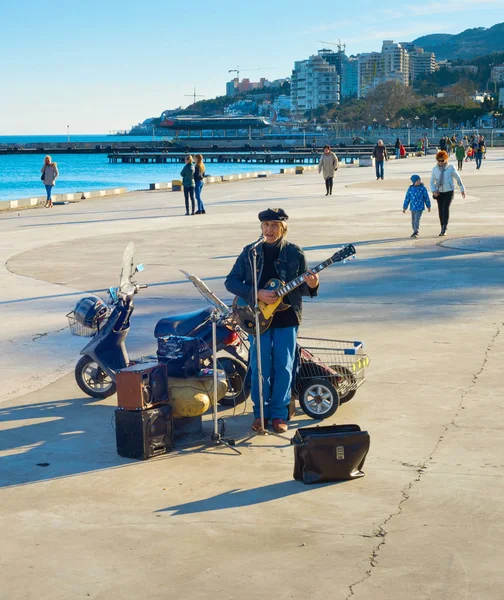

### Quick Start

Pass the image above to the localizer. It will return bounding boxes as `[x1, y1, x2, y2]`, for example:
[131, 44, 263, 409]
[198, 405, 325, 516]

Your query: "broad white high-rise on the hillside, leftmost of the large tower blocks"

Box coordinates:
[291, 55, 339, 112]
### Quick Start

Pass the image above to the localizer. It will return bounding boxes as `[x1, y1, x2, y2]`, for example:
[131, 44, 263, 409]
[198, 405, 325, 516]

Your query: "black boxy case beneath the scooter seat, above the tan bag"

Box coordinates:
[157, 335, 200, 377]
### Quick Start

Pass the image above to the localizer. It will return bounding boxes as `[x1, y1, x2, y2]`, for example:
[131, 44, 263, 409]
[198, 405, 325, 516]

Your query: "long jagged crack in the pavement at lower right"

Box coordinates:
[345, 323, 504, 600]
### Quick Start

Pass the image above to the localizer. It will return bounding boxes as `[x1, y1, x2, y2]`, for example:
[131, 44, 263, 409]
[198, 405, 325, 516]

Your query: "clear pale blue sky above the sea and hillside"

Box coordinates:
[0, 0, 504, 135]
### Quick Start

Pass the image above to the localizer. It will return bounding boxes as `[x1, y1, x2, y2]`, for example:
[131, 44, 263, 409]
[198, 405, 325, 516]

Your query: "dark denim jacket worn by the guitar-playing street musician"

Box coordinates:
[224, 238, 318, 323]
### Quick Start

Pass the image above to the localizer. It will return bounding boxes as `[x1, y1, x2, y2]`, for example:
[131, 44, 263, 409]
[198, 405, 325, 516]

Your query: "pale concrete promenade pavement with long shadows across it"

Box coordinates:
[0, 154, 504, 600]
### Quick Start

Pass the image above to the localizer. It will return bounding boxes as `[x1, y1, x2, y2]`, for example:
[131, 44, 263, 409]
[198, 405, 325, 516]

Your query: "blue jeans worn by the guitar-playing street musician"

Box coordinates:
[250, 327, 298, 420]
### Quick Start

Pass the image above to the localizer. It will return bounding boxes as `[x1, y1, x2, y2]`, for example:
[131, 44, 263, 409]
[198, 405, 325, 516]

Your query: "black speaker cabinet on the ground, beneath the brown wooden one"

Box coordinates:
[115, 404, 173, 460]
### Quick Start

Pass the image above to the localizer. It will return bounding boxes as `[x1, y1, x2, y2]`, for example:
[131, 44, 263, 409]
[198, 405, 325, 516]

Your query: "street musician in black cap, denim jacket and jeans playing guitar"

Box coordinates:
[225, 208, 319, 433]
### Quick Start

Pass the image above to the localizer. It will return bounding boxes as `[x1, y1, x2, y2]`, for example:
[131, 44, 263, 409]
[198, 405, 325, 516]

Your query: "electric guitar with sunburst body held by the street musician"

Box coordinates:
[233, 244, 356, 334]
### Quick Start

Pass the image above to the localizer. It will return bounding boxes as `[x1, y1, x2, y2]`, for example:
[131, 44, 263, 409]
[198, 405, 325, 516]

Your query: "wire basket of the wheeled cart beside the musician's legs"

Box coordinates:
[296, 337, 370, 402]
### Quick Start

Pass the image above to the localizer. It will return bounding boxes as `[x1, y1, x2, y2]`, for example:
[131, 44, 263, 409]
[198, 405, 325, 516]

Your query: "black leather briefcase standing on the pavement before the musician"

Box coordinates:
[291, 425, 369, 483]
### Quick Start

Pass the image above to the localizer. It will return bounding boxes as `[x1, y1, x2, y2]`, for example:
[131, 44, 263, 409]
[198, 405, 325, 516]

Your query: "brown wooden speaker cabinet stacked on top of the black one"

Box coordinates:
[116, 362, 168, 410]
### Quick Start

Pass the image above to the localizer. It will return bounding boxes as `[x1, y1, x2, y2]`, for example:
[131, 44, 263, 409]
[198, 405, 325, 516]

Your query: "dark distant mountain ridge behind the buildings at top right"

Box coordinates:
[413, 23, 504, 60]
